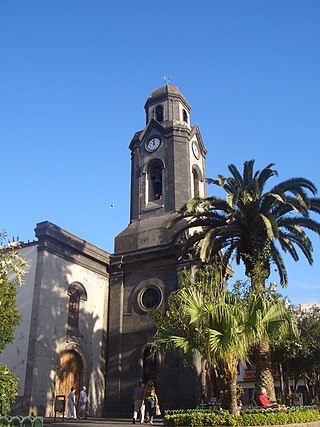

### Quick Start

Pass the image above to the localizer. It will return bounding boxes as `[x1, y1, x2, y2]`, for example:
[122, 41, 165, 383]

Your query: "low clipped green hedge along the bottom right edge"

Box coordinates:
[163, 407, 319, 427]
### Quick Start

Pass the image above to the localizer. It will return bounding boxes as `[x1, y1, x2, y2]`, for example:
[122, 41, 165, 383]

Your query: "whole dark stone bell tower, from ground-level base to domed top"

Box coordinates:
[105, 85, 206, 416]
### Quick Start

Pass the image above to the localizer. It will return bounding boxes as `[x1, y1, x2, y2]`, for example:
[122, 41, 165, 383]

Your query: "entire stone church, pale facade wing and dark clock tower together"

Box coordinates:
[0, 85, 206, 417]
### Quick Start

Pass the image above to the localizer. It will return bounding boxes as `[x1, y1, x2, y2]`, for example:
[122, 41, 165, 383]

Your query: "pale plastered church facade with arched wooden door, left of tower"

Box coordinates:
[11, 223, 108, 416]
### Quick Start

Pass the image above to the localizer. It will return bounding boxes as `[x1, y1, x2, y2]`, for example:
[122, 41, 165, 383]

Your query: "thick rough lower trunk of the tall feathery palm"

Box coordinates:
[256, 341, 276, 401]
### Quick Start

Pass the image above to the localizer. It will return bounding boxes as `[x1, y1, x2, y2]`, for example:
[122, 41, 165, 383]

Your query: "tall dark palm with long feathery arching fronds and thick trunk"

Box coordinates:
[170, 160, 320, 398]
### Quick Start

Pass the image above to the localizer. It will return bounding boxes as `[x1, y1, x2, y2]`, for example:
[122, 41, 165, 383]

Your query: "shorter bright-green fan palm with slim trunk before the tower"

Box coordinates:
[152, 286, 289, 414]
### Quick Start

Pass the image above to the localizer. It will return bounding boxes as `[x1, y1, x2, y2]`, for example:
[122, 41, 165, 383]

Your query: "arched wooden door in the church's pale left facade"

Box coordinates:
[59, 351, 82, 410]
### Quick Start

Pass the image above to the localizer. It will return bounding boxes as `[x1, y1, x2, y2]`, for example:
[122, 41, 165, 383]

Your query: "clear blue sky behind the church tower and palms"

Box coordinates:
[0, 0, 320, 304]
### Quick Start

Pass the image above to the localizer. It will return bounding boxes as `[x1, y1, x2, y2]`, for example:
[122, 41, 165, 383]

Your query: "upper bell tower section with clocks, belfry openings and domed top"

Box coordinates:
[115, 85, 206, 253]
